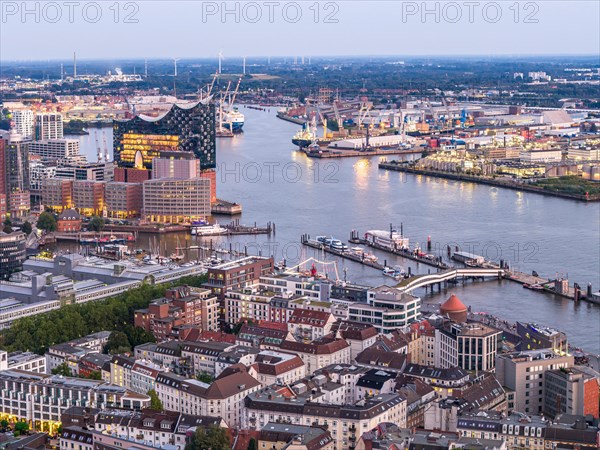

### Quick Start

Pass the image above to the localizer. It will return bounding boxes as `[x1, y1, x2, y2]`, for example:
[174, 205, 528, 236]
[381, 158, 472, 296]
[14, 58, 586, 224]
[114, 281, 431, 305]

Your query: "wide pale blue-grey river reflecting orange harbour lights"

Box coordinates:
[65, 107, 600, 353]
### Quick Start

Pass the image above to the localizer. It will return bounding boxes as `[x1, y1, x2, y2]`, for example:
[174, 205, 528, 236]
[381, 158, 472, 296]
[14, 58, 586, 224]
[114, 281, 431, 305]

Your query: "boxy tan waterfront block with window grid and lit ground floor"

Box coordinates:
[142, 178, 211, 223]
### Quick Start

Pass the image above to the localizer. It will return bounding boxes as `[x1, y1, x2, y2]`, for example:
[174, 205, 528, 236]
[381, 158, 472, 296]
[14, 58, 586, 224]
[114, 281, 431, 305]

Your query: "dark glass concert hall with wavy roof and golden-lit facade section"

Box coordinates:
[113, 102, 216, 170]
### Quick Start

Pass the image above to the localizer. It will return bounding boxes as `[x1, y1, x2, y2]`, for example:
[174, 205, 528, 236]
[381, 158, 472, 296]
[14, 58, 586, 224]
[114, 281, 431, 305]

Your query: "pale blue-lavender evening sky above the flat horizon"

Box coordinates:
[0, 0, 600, 61]
